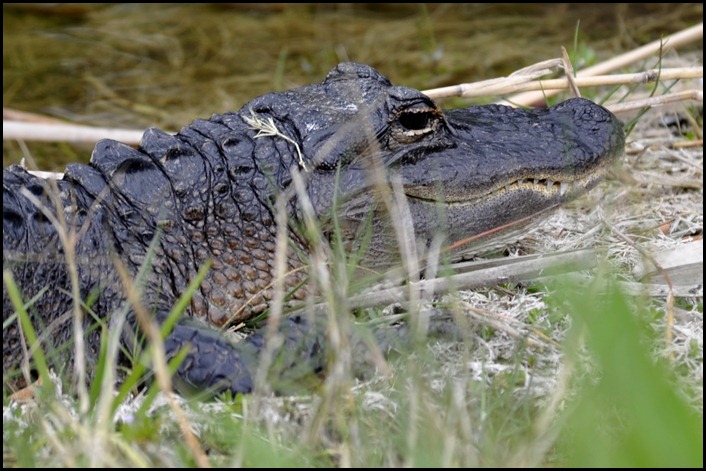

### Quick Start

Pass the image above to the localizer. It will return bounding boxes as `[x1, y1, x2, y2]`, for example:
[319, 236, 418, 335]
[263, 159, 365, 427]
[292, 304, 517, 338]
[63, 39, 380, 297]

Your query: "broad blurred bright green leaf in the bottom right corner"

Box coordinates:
[559, 280, 703, 468]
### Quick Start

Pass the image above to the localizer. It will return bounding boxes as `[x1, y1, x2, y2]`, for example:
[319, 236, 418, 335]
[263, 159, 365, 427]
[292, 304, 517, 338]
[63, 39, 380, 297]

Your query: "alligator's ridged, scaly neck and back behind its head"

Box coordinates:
[3, 114, 305, 386]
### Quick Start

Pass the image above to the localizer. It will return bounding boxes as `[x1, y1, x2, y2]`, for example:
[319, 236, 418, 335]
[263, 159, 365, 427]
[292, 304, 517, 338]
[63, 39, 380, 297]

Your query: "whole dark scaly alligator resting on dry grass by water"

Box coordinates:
[3, 63, 624, 393]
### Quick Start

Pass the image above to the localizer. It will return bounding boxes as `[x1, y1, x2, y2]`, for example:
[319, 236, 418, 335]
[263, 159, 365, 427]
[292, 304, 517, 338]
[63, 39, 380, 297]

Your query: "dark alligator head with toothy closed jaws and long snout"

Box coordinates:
[244, 63, 624, 267]
